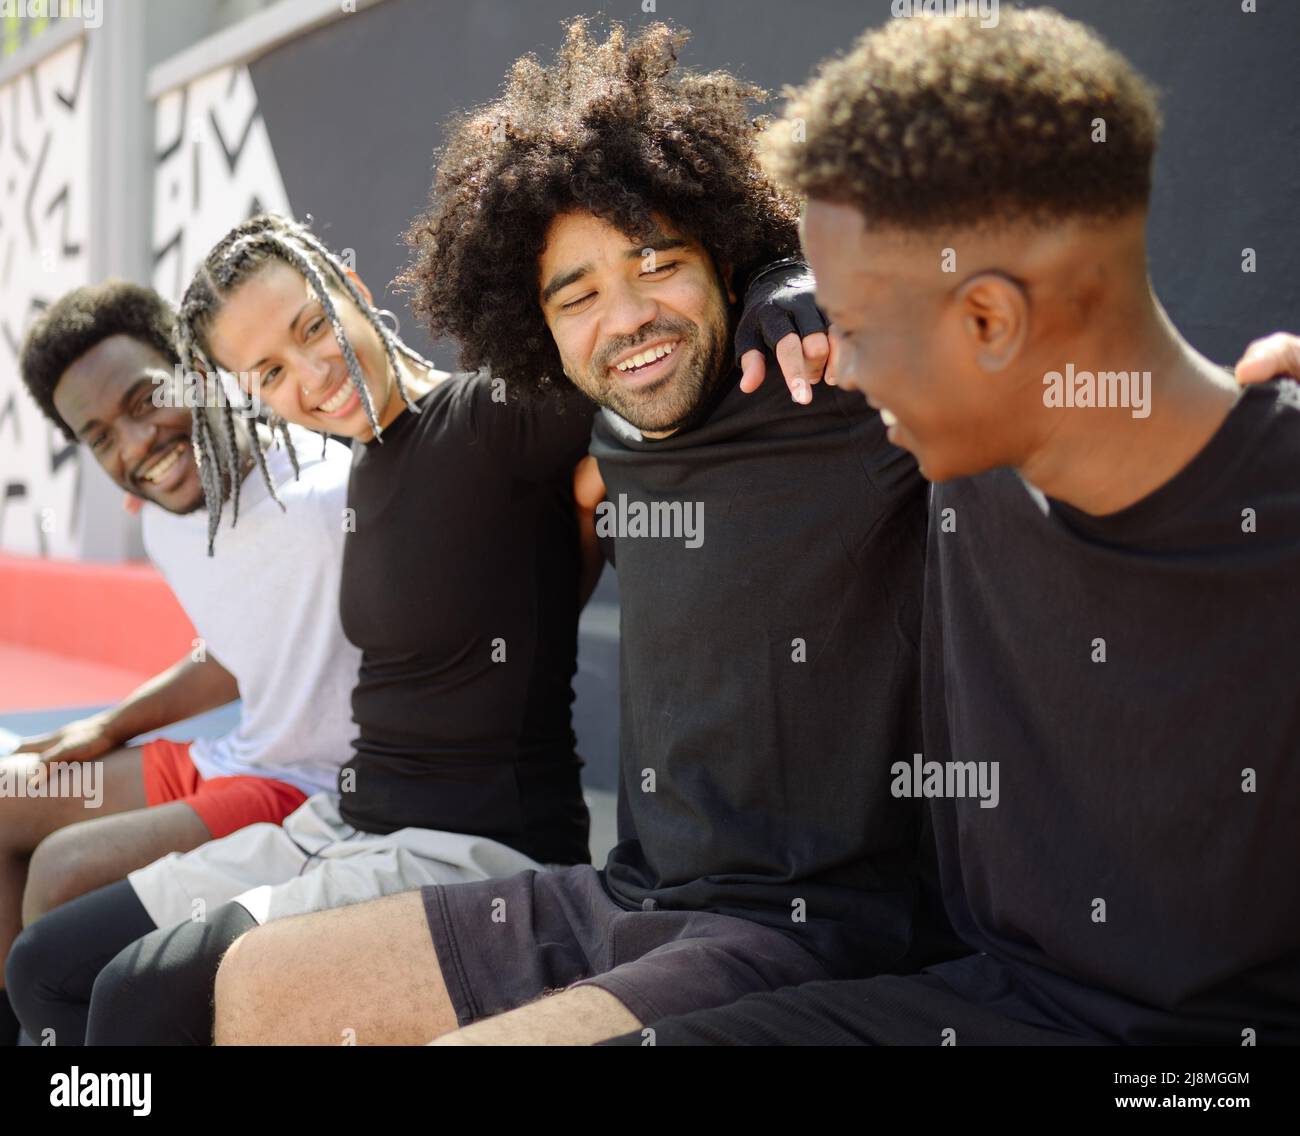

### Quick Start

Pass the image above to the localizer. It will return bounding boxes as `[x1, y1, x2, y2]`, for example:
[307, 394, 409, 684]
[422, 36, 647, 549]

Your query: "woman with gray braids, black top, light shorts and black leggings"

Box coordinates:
[6, 216, 594, 1045]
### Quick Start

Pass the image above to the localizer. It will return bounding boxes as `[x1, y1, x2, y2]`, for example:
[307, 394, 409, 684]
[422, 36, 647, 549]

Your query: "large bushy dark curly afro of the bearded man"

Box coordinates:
[398, 18, 798, 391]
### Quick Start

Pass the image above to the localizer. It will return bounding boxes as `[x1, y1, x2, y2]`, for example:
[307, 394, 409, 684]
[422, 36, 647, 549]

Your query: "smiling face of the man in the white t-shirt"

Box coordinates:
[55, 335, 203, 513]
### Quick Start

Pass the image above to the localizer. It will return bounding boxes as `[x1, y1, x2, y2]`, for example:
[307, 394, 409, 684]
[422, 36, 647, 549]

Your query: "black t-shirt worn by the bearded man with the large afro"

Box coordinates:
[592, 360, 948, 976]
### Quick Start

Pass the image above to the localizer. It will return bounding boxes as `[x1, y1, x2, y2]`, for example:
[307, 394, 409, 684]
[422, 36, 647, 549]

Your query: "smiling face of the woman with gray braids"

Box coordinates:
[207, 260, 400, 442]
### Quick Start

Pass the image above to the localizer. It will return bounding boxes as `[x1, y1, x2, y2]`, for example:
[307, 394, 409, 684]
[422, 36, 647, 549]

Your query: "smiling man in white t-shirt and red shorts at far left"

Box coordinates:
[0, 281, 360, 1044]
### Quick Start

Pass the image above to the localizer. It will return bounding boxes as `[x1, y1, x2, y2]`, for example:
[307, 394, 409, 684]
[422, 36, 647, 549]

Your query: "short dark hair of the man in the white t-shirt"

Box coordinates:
[18, 279, 179, 442]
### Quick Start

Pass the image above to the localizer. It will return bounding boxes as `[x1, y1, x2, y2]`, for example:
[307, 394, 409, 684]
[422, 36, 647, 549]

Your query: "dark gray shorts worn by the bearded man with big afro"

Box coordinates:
[420, 864, 828, 1026]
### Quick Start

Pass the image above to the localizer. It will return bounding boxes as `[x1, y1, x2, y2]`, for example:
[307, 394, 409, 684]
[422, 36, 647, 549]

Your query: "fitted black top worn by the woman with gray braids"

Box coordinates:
[339, 374, 593, 863]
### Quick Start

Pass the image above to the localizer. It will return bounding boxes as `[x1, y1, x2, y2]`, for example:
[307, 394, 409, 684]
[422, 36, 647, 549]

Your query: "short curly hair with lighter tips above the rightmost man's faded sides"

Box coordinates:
[763, 8, 1160, 230]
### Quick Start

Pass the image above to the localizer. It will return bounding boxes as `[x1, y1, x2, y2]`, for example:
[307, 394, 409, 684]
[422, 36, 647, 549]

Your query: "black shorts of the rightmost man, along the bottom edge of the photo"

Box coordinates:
[602, 955, 1105, 1046]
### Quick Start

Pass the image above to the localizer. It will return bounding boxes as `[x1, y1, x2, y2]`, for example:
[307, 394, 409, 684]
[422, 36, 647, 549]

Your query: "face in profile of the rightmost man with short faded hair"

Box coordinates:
[801, 200, 1011, 481]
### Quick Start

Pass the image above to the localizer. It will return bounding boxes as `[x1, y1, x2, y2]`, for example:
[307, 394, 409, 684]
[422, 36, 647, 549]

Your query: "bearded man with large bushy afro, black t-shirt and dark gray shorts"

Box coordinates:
[200, 21, 956, 1044]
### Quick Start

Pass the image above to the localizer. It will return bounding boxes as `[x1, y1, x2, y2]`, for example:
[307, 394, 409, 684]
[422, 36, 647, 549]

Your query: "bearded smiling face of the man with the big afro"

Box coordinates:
[538, 212, 735, 437]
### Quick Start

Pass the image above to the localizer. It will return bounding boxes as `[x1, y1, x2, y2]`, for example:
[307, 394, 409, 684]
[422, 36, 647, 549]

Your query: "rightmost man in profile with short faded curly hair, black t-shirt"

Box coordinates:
[605, 10, 1300, 1045]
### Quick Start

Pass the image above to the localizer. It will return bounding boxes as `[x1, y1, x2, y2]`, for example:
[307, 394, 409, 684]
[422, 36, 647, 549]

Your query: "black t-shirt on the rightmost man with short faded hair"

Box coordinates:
[924, 381, 1300, 1045]
